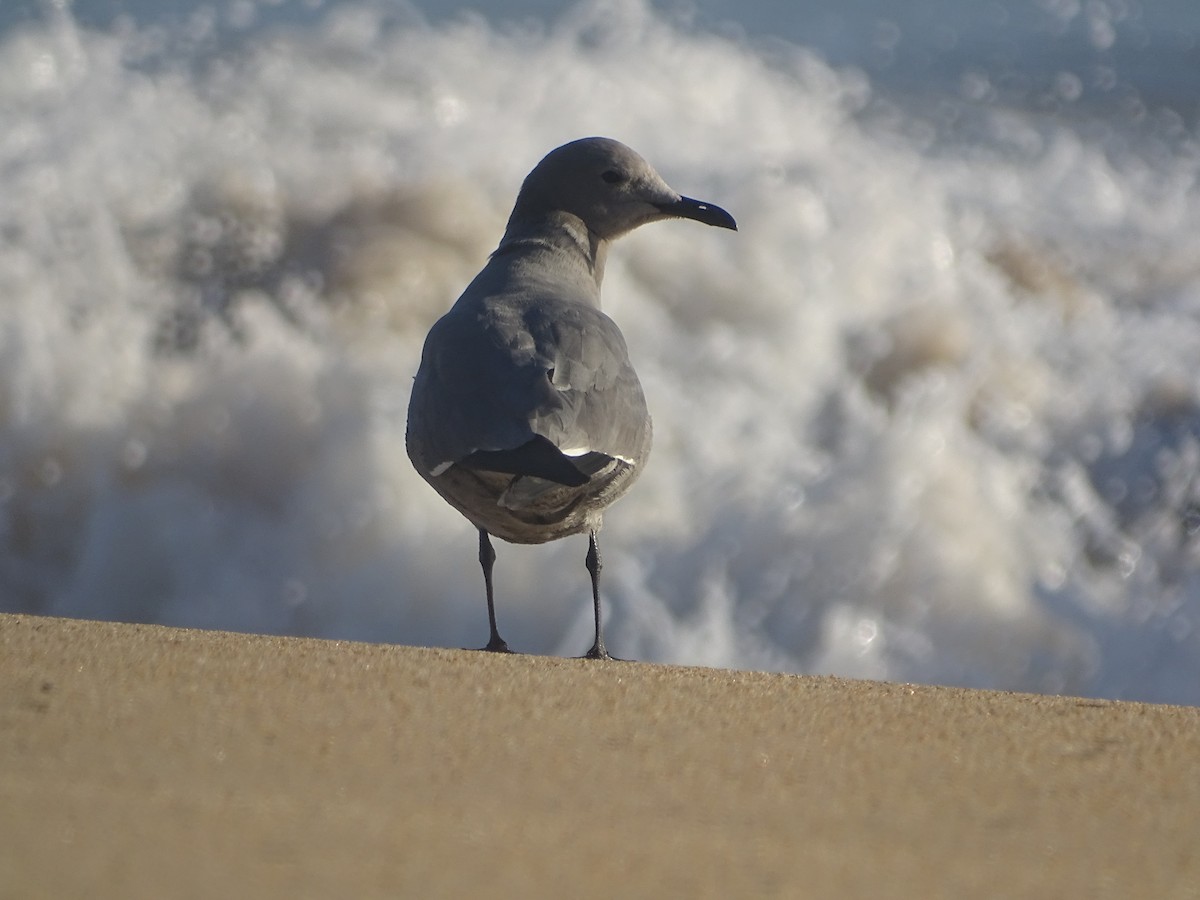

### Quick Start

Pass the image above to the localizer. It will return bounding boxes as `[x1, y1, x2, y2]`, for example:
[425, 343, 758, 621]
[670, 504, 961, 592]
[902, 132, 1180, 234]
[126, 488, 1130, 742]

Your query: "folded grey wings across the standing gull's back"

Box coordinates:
[408, 298, 650, 474]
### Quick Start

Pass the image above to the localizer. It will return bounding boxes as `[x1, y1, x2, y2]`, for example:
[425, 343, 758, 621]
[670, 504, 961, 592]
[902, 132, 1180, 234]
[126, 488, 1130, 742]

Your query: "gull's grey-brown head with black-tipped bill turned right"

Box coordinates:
[512, 138, 737, 240]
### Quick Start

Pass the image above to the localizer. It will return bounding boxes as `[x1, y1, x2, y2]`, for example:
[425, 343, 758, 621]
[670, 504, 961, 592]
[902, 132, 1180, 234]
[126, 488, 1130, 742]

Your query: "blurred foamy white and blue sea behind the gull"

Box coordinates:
[0, 0, 1200, 704]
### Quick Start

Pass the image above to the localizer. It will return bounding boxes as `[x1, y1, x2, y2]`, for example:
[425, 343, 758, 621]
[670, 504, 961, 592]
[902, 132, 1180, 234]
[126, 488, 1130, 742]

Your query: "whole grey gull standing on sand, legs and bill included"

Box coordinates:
[407, 138, 737, 659]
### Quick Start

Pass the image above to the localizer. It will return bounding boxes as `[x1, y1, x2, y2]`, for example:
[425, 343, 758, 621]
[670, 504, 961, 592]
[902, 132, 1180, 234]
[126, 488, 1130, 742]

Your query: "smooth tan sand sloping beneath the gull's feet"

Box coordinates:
[0, 616, 1200, 900]
